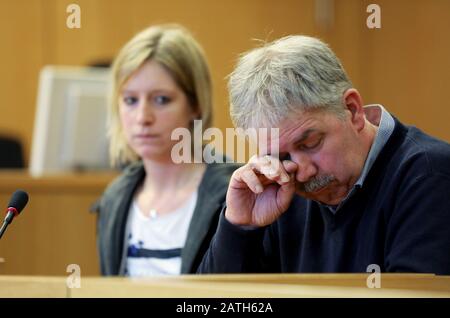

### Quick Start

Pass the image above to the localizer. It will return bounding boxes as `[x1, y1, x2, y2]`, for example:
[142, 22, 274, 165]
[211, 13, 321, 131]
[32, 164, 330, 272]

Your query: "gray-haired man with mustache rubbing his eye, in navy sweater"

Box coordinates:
[198, 36, 450, 275]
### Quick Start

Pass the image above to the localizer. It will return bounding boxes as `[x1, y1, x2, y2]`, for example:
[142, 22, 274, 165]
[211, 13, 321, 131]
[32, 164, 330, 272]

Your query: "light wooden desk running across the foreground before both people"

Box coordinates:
[0, 274, 450, 298]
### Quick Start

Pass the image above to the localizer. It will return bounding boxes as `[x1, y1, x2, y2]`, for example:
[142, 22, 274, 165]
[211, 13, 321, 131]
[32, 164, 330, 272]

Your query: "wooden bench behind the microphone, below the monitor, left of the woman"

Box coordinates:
[0, 171, 117, 276]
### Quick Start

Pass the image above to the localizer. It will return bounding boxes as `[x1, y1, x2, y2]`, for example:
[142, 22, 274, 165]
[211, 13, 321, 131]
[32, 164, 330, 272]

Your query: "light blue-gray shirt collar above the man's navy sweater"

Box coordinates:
[325, 104, 395, 214]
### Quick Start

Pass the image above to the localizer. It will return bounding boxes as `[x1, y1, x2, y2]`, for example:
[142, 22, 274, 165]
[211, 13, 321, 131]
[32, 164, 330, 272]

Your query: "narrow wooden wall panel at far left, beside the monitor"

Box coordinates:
[0, 0, 43, 164]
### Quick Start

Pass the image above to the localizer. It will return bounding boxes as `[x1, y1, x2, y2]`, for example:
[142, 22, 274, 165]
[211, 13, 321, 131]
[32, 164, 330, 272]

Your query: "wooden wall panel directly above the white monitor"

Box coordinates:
[42, 0, 133, 65]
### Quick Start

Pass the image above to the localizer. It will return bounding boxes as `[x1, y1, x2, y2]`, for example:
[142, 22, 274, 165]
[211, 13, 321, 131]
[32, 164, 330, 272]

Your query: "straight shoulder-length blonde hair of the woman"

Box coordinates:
[108, 24, 212, 166]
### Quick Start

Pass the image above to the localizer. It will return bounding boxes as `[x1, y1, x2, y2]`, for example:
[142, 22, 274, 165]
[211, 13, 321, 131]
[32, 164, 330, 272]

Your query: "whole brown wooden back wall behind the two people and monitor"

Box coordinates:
[0, 0, 450, 166]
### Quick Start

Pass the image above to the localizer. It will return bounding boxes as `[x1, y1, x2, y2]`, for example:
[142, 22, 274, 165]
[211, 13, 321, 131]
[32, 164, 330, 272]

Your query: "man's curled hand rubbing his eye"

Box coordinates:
[225, 155, 297, 227]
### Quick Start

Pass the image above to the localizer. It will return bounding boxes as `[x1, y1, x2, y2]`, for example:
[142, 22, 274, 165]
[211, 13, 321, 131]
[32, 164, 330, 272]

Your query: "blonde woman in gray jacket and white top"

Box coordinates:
[96, 25, 236, 276]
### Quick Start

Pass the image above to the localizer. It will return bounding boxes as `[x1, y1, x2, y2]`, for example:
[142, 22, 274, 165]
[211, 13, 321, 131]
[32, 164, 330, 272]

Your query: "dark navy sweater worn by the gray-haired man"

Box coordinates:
[198, 119, 450, 275]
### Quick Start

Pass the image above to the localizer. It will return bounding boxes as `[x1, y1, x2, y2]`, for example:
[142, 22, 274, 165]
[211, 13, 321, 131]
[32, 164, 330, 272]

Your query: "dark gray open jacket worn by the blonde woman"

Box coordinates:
[93, 162, 238, 276]
